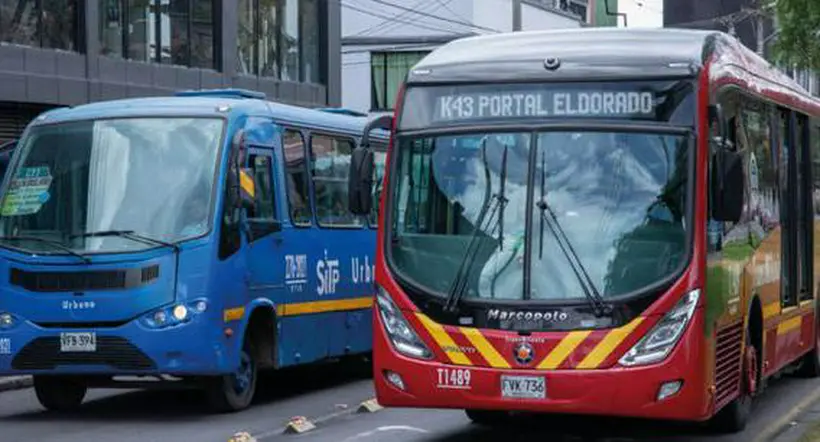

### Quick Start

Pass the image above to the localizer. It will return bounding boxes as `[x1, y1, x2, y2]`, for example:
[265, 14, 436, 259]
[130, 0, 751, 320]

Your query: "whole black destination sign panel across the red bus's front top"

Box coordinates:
[399, 81, 694, 130]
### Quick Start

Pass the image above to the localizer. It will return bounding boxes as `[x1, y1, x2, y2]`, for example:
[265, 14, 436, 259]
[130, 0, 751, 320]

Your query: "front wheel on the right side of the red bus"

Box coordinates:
[713, 322, 762, 433]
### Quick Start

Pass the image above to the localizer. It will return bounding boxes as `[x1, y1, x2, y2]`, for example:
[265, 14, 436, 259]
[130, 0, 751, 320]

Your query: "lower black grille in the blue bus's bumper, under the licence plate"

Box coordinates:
[11, 336, 156, 370]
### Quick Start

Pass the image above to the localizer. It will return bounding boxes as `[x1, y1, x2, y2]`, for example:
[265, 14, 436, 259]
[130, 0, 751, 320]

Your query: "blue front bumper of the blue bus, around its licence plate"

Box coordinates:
[0, 317, 238, 376]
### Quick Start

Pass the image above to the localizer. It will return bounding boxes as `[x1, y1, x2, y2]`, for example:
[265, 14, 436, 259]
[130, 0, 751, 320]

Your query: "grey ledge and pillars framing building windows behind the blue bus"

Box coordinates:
[0, 0, 341, 106]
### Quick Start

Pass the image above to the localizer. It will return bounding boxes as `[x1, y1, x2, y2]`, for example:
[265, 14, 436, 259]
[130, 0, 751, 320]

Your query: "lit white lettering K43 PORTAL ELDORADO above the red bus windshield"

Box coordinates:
[434, 91, 655, 122]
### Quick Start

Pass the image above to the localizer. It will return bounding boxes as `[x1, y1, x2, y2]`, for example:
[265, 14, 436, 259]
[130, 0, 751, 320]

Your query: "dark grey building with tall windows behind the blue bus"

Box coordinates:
[0, 0, 341, 143]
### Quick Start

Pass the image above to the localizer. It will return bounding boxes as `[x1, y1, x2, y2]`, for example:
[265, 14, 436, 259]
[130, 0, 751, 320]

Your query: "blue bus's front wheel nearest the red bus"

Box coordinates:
[206, 341, 258, 413]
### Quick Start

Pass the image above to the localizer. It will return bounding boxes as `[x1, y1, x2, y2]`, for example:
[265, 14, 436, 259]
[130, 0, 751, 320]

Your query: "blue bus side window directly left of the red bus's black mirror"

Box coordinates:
[310, 135, 362, 227]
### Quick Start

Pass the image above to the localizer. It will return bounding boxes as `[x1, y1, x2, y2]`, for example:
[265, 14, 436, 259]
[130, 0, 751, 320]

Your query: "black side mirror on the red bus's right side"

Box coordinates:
[711, 148, 746, 223]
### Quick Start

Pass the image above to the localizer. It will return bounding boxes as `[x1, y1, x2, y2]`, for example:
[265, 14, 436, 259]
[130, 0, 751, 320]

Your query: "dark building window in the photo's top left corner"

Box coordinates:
[0, 0, 80, 51]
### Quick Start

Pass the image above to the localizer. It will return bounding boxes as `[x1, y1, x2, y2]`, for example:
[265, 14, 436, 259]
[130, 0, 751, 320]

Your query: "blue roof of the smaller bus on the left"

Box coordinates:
[27, 94, 387, 138]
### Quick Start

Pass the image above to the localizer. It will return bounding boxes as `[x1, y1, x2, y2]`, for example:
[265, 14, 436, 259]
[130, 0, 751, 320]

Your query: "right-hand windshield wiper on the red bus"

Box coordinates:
[536, 151, 612, 317]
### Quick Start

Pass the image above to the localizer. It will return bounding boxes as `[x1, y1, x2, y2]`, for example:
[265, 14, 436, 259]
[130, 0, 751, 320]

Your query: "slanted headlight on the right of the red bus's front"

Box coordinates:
[618, 289, 700, 366]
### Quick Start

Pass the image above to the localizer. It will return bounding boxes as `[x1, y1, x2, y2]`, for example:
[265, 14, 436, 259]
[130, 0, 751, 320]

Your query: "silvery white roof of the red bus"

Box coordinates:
[407, 28, 820, 115]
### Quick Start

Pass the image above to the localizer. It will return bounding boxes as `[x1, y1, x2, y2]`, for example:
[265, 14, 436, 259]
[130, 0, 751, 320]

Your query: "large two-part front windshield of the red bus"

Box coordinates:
[390, 131, 691, 300]
